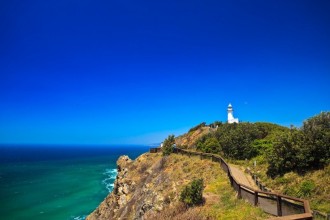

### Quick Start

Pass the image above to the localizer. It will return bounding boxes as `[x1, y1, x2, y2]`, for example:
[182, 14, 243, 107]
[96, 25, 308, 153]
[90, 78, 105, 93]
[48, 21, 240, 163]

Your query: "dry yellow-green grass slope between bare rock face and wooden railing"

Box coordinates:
[141, 154, 269, 220]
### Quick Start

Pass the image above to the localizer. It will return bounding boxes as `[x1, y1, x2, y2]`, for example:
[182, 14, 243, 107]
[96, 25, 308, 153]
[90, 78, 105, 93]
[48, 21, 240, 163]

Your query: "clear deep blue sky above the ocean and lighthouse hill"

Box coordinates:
[0, 0, 330, 144]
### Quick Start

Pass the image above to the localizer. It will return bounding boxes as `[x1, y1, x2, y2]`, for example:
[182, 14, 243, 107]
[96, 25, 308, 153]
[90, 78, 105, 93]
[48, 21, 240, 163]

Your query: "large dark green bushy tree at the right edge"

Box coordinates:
[267, 112, 330, 177]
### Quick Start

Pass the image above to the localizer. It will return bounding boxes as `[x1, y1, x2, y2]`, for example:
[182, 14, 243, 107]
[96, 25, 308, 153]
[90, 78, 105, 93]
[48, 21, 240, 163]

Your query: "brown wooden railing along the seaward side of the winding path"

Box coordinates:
[150, 148, 313, 220]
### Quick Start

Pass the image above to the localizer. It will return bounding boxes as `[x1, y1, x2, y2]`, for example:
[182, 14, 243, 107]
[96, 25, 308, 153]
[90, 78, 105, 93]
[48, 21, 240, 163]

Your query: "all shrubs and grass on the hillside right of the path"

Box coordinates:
[184, 112, 330, 212]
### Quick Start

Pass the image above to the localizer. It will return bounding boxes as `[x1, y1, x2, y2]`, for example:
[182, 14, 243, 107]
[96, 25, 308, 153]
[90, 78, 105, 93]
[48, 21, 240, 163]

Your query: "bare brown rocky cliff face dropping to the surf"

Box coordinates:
[87, 153, 174, 220]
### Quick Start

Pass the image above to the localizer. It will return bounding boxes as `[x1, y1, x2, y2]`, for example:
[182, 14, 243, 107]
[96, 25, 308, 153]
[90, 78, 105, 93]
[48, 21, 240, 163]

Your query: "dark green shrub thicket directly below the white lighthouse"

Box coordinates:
[196, 123, 289, 160]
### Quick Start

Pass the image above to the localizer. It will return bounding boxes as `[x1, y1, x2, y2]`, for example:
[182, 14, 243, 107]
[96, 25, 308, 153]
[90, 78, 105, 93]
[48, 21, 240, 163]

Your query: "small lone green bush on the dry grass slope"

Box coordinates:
[180, 179, 204, 207]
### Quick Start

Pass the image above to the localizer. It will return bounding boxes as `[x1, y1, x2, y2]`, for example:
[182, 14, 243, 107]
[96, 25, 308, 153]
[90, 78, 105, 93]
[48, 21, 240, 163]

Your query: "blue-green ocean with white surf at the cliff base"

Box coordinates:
[0, 146, 149, 220]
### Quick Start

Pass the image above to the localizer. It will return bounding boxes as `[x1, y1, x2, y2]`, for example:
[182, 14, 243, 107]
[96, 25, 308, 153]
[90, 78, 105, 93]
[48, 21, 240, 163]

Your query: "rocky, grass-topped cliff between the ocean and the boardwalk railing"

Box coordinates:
[87, 153, 264, 220]
